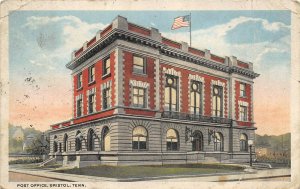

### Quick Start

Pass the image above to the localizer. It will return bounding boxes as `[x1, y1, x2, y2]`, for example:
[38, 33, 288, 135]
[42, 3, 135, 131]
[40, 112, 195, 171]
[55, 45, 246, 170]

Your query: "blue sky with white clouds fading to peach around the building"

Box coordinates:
[9, 11, 291, 133]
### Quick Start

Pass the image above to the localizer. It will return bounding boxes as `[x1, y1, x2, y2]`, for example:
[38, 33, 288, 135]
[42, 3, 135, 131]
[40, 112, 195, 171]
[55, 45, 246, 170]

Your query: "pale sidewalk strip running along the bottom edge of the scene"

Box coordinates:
[9, 168, 291, 182]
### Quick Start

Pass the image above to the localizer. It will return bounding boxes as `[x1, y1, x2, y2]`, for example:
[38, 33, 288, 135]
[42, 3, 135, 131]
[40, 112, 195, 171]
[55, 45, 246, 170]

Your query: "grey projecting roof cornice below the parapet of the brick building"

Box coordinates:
[66, 28, 259, 79]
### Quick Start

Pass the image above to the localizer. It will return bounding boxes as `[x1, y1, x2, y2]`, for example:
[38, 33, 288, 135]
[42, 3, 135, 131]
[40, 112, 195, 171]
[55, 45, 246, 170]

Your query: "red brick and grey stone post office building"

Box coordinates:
[50, 16, 258, 166]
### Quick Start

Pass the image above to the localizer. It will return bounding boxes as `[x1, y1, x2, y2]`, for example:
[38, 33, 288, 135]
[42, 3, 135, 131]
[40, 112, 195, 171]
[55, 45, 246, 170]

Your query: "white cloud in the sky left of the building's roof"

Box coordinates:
[23, 16, 105, 70]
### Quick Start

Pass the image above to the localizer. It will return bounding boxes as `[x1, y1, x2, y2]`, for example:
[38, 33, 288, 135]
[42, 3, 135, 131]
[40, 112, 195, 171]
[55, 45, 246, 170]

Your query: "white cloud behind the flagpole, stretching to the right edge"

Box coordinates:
[163, 17, 290, 67]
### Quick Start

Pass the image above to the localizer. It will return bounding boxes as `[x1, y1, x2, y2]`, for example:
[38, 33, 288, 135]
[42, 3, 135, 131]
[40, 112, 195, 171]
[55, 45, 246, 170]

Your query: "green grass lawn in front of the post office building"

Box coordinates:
[56, 164, 243, 178]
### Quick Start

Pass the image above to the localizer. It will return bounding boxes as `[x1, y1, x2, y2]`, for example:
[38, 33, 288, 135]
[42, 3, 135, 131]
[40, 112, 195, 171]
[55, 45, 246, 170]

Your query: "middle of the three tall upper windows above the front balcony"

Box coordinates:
[190, 81, 202, 115]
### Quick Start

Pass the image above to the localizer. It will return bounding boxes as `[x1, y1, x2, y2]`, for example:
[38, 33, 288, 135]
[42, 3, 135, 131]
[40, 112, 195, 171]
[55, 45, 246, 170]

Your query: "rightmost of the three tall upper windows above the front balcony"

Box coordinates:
[212, 85, 223, 117]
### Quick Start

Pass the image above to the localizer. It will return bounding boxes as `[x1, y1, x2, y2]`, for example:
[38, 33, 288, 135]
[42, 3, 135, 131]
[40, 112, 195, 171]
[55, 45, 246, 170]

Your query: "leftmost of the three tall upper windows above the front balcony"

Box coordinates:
[165, 75, 178, 111]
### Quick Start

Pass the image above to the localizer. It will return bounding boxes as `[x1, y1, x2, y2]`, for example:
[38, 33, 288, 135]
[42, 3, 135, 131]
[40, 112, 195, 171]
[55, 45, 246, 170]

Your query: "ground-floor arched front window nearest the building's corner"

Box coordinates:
[132, 126, 148, 150]
